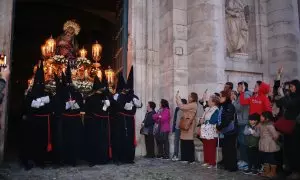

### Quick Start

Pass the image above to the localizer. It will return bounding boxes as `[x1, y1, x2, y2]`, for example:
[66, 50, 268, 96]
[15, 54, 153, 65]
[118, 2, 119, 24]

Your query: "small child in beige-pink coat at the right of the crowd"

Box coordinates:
[258, 112, 280, 178]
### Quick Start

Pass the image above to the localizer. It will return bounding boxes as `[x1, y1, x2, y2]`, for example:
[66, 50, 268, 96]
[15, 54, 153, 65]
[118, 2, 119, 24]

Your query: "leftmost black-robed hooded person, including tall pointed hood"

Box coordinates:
[21, 62, 53, 169]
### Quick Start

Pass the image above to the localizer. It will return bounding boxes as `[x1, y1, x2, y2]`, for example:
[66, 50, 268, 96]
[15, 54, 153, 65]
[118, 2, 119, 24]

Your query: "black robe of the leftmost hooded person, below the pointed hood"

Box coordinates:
[21, 92, 53, 166]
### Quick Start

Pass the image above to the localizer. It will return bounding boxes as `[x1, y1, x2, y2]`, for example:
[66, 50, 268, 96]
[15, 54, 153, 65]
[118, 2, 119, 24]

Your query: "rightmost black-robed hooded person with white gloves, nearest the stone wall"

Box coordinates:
[113, 67, 142, 163]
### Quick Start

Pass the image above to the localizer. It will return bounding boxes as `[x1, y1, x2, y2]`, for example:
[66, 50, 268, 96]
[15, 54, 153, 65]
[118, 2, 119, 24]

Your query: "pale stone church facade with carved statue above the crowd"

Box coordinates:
[0, 0, 300, 160]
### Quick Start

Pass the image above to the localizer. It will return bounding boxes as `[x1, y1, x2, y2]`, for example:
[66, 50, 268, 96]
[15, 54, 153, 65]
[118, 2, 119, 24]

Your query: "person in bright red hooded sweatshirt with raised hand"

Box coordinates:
[240, 82, 272, 114]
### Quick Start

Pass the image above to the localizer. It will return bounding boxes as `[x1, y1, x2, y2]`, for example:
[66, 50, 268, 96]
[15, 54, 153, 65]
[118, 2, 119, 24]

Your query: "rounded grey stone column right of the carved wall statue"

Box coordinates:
[267, 0, 300, 80]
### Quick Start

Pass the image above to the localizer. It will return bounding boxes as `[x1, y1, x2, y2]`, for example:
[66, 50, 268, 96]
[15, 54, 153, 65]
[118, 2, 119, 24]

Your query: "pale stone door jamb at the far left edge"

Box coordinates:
[0, 0, 13, 163]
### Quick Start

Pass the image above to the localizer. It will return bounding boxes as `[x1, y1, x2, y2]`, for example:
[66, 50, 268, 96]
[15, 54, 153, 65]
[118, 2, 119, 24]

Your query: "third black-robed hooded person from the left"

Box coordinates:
[85, 71, 112, 166]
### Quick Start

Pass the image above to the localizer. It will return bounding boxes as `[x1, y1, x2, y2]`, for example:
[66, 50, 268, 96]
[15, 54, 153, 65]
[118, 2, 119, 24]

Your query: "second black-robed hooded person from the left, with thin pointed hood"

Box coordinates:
[60, 64, 83, 166]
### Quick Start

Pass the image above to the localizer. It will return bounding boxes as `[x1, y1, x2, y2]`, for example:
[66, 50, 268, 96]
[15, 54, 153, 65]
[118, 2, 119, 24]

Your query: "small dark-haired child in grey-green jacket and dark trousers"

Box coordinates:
[244, 113, 260, 175]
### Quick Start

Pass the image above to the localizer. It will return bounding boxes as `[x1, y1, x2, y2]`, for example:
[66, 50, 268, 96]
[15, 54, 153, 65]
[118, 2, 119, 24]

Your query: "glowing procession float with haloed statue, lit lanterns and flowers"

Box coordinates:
[28, 20, 115, 95]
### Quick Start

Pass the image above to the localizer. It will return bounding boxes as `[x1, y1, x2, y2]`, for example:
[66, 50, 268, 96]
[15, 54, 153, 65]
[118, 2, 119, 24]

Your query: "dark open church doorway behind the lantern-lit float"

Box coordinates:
[0, 0, 128, 161]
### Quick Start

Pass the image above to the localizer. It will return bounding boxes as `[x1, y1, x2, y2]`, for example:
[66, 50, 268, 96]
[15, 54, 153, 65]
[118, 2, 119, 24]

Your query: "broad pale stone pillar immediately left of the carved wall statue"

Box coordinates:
[187, 0, 226, 96]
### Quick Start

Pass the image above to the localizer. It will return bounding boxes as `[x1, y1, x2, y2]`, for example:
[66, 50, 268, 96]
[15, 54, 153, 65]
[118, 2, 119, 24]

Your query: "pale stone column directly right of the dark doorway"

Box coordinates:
[127, 0, 160, 156]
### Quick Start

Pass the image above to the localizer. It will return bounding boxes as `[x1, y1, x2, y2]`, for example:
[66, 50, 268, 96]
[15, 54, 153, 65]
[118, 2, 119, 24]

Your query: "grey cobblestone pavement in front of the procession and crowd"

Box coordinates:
[0, 158, 260, 180]
